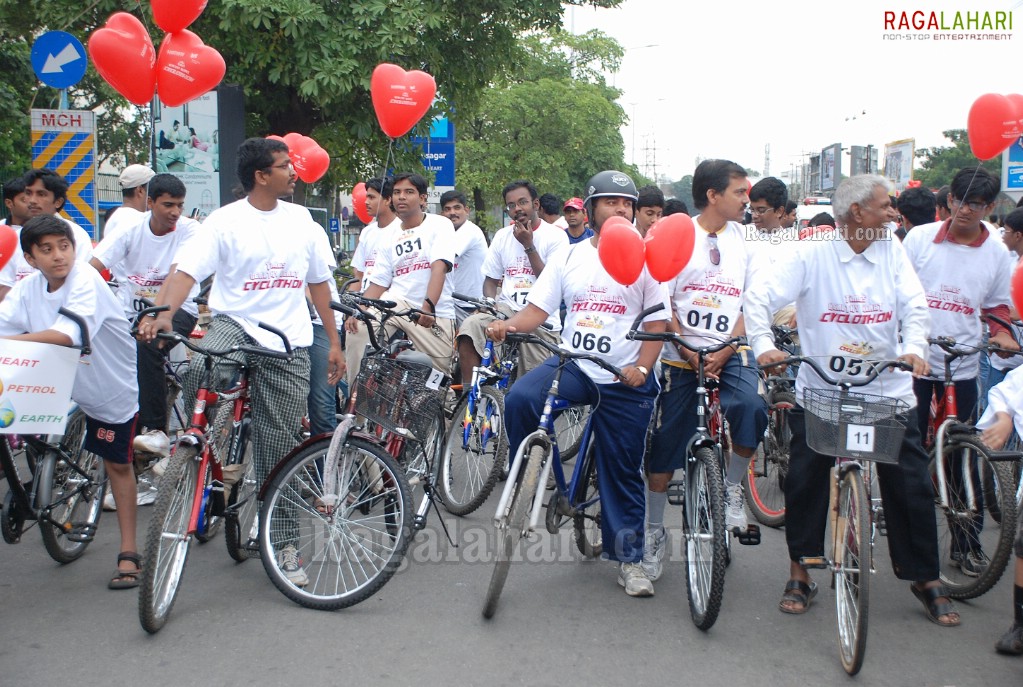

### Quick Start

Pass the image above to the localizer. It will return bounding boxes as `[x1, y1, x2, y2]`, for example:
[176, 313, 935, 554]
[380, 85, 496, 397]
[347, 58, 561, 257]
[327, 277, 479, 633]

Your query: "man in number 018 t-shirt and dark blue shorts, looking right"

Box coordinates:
[643, 159, 767, 580]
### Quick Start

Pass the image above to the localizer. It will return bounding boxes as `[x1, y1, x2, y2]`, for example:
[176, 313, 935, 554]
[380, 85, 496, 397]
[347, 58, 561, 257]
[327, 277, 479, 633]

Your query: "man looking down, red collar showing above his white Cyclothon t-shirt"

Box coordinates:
[902, 167, 1019, 577]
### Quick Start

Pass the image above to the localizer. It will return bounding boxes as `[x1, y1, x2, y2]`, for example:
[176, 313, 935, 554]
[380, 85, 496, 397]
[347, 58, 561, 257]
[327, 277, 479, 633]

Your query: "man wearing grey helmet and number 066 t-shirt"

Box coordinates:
[488, 171, 670, 596]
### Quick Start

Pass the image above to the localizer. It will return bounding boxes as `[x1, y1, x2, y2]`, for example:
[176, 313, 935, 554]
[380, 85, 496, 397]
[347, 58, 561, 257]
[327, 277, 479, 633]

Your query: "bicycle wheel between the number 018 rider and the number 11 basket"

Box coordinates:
[745, 392, 796, 528]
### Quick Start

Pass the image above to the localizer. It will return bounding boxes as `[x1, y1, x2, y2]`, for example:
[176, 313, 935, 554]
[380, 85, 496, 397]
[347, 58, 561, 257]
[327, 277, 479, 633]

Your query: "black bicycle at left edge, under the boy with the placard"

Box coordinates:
[0, 308, 106, 564]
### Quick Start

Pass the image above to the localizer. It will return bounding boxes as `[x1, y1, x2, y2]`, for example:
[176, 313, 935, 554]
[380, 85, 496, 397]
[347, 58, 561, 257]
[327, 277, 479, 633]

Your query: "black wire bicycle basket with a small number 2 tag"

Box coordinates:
[355, 356, 446, 441]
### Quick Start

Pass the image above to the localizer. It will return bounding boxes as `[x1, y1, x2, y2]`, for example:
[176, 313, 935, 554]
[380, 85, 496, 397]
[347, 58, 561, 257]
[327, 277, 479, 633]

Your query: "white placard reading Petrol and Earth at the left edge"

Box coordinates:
[0, 339, 79, 434]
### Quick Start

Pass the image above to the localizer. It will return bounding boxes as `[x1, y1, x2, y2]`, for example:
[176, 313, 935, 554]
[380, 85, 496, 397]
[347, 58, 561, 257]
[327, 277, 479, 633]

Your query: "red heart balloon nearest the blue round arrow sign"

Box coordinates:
[89, 12, 157, 105]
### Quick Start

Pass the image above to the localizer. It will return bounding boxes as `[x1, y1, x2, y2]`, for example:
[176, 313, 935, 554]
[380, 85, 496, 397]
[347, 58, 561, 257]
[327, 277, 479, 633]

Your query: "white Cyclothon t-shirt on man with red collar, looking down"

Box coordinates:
[902, 222, 1012, 379]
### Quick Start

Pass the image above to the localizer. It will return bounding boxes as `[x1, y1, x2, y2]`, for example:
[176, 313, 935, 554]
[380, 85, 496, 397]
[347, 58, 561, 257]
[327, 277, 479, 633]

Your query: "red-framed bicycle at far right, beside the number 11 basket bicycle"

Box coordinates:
[925, 336, 1020, 599]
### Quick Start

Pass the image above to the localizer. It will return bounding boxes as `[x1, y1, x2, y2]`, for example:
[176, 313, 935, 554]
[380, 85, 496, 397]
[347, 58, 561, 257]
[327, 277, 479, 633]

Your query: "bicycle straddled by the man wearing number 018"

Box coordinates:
[629, 306, 760, 631]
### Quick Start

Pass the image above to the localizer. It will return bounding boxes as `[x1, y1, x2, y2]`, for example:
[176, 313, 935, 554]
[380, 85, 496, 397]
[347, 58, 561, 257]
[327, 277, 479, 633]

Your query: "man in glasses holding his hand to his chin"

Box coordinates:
[458, 179, 569, 380]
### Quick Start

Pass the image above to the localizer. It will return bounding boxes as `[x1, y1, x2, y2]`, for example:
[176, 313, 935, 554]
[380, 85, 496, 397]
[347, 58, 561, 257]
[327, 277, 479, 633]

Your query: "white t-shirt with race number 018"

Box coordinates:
[662, 218, 765, 361]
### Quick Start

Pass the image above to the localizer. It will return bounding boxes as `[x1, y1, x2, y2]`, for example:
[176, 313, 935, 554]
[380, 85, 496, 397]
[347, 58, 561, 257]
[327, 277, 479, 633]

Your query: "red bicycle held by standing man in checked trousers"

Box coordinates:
[136, 306, 293, 634]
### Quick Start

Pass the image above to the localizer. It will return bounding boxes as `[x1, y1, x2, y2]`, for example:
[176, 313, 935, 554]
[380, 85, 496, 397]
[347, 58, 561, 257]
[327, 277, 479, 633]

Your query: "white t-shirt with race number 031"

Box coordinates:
[369, 214, 455, 320]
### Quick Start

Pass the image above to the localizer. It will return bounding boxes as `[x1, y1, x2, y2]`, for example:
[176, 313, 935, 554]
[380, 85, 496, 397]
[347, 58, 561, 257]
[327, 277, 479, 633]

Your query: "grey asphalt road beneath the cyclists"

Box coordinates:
[0, 488, 1023, 687]
